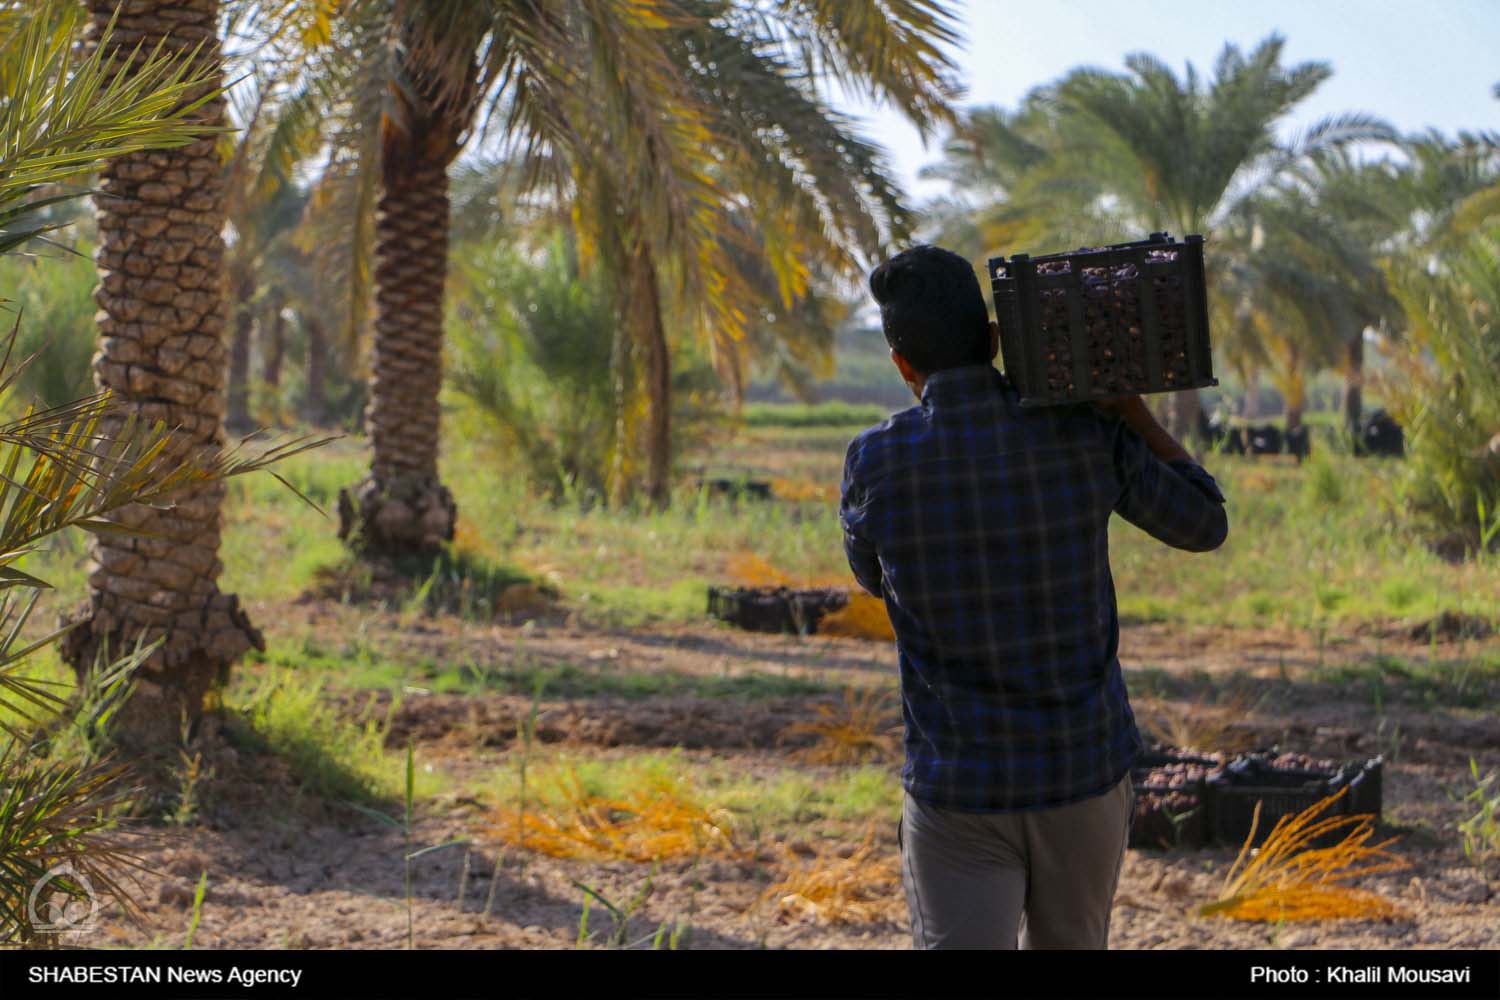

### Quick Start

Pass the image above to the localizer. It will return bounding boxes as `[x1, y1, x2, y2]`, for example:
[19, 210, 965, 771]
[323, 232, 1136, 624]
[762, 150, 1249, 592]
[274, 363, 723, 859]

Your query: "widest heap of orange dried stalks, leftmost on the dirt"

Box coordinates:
[486, 772, 743, 862]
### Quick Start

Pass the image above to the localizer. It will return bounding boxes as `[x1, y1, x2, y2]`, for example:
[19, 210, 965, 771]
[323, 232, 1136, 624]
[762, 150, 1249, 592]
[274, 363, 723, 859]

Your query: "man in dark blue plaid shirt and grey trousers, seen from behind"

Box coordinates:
[840, 246, 1229, 949]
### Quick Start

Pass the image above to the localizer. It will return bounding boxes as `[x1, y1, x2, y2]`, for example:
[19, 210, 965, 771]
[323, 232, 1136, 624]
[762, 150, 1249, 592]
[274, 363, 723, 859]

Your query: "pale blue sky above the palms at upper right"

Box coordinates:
[846, 0, 1500, 201]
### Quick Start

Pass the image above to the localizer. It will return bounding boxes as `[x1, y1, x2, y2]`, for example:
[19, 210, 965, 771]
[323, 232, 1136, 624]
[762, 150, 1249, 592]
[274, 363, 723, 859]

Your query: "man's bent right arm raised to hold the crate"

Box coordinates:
[1100, 396, 1229, 552]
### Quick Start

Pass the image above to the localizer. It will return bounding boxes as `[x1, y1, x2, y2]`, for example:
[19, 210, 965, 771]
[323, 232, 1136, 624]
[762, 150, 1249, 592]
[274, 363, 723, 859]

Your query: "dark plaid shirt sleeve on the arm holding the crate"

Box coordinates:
[1115, 423, 1229, 552]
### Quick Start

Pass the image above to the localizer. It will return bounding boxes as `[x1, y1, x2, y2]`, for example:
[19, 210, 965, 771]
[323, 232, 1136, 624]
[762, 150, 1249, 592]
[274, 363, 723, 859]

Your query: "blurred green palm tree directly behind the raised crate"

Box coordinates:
[924, 34, 1395, 433]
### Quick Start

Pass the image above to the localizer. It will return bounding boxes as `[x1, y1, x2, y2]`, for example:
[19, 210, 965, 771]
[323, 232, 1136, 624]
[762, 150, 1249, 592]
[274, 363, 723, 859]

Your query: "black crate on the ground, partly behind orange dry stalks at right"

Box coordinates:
[1208, 751, 1382, 847]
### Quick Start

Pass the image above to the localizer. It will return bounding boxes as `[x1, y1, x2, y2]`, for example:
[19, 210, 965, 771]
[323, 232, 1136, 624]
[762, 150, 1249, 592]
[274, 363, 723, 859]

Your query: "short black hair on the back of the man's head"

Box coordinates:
[870, 246, 990, 375]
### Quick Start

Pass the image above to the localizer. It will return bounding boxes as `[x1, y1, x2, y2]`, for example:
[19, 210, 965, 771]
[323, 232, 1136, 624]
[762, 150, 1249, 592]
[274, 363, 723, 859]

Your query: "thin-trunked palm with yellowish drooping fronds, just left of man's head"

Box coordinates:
[573, 3, 954, 507]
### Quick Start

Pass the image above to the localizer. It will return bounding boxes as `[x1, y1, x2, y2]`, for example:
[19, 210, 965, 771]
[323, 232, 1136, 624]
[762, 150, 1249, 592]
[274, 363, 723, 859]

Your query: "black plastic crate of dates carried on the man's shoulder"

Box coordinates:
[989, 232, 1218, 406]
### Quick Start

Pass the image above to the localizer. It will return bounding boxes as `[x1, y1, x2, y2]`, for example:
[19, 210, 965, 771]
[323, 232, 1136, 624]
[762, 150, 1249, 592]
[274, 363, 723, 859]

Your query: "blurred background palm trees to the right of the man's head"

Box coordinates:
[926, 36, 1500, 552]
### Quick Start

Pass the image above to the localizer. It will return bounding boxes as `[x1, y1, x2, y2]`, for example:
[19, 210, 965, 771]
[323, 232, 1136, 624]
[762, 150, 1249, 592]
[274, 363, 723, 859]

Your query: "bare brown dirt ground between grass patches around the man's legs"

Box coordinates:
[64, 601, 1500, 949]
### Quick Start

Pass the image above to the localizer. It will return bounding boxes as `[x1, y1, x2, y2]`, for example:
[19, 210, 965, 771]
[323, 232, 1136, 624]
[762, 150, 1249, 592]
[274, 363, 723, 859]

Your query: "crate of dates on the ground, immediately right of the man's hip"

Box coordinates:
[1130, 747, 1227, 849]
